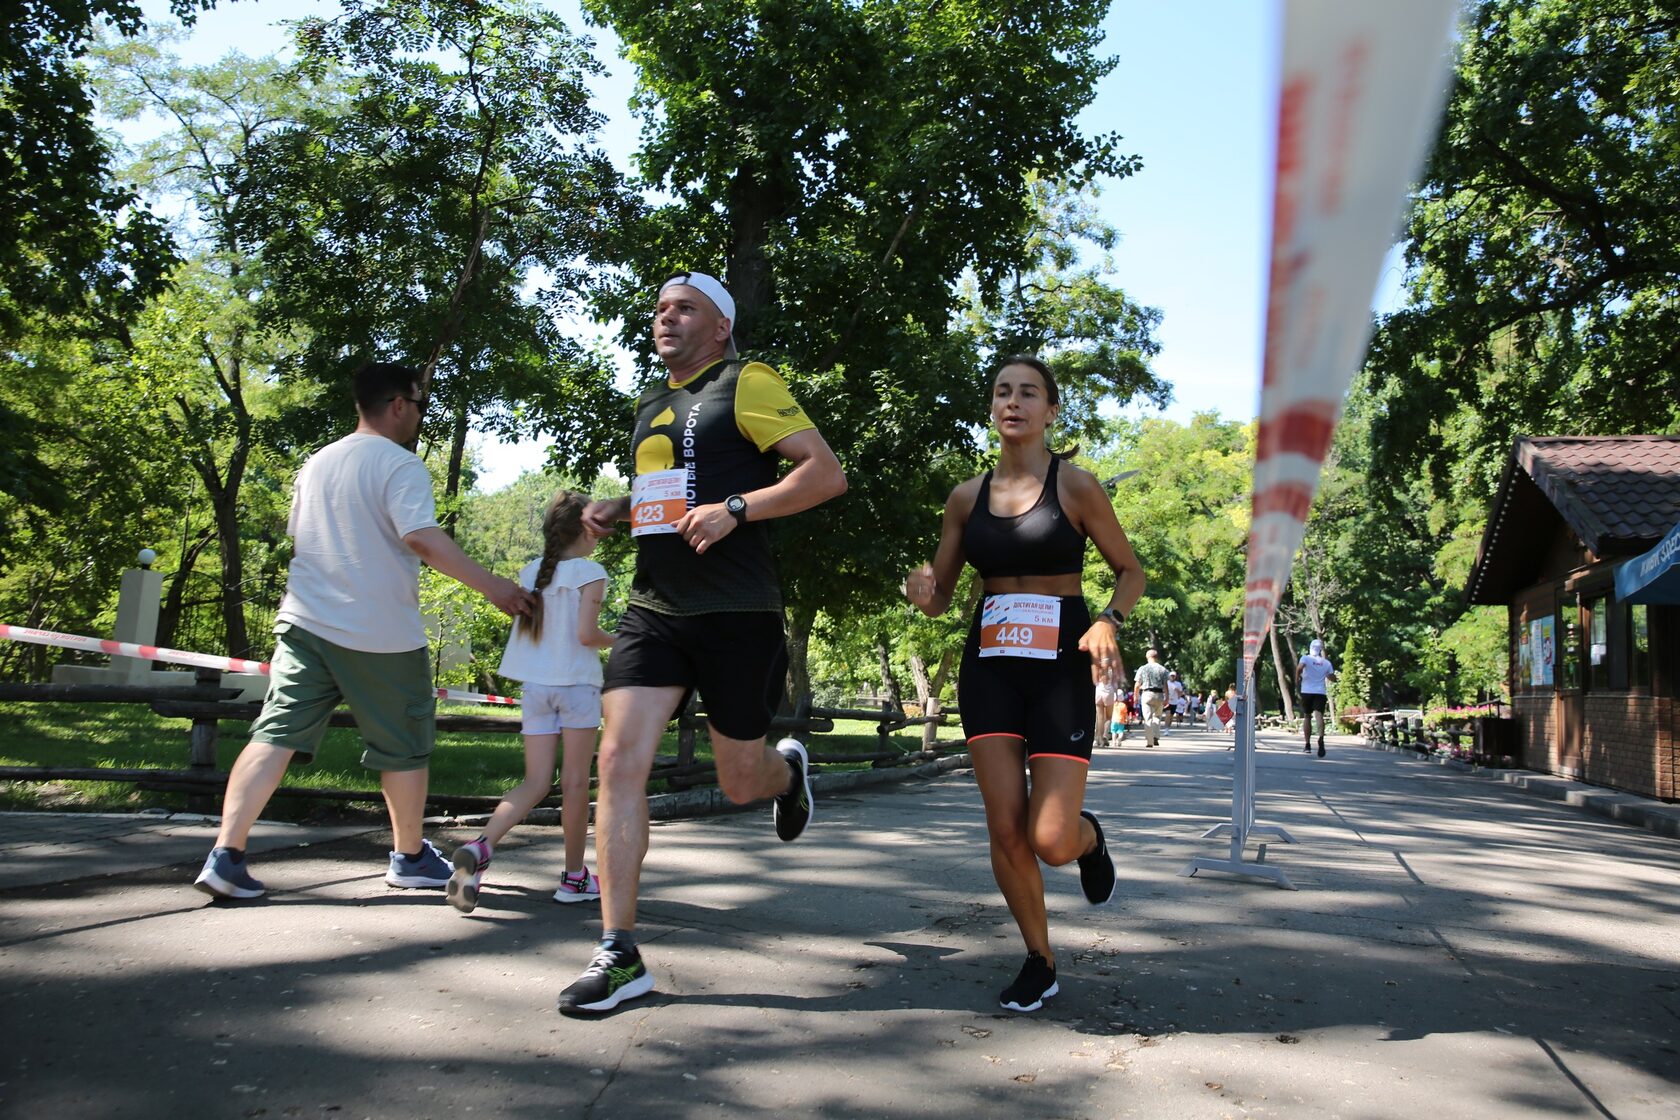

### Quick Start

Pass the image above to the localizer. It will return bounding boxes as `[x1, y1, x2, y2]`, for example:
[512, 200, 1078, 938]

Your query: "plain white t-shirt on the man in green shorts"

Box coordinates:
[276, 433, 437, 653]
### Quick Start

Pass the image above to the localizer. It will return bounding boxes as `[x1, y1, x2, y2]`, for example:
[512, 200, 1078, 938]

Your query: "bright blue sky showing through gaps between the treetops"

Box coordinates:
[146, 0, 1396, 489]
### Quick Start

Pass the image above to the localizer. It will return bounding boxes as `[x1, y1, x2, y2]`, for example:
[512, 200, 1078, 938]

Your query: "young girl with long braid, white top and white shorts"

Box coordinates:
[445, 490, 613, 913]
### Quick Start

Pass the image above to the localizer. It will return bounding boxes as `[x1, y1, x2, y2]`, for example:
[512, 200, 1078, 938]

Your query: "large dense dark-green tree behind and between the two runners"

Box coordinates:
[585, 0, 1136, 688]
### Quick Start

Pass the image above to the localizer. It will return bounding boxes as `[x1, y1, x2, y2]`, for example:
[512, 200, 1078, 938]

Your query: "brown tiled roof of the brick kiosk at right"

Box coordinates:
[1467, 435, 1680, 603]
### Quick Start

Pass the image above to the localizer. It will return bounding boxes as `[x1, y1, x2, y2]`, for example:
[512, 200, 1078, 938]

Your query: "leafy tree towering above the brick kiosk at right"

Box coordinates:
[1371, 0, 1680, 495]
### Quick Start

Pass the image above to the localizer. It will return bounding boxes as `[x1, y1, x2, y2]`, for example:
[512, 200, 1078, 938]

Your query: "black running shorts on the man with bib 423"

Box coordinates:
[601, 606, 788, 741]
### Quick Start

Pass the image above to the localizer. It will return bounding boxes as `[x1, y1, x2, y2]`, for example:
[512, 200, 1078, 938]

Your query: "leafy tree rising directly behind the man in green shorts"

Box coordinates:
[240, 0, 630, 513]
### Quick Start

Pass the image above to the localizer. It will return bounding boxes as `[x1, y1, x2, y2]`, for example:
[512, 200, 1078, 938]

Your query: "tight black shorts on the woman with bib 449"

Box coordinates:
[956, 594, 1097, 764]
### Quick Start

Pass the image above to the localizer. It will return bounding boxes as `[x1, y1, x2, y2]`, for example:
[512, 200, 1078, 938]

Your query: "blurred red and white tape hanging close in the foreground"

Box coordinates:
[1243, 0, 1458, 680]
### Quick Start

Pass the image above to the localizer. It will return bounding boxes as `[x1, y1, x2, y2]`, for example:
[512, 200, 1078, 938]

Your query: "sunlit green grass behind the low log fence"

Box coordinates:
[0, 702, 951, 818]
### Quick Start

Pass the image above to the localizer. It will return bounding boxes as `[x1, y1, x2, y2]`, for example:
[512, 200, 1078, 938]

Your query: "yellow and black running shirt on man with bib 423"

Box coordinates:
[630, 361, 816, 615]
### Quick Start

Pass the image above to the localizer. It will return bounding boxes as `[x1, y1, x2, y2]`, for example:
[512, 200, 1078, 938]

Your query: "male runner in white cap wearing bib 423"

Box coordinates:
[559, 272, 845, 1014]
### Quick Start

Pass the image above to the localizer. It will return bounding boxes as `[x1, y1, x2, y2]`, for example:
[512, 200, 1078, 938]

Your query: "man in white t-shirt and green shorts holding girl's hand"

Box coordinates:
[193, 363, 531, 898]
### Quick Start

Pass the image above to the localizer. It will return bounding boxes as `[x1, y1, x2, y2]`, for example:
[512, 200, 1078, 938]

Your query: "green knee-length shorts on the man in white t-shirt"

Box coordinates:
[250, 623, 437, 771]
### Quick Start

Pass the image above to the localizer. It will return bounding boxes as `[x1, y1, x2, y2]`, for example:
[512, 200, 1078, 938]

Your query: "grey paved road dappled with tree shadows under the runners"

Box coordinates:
[0, 732, 1680, 1120]
